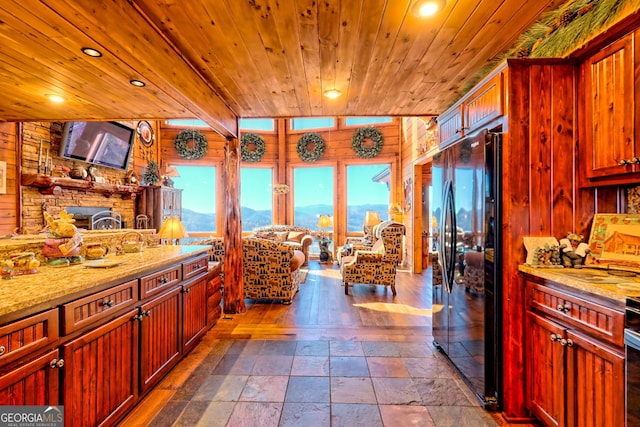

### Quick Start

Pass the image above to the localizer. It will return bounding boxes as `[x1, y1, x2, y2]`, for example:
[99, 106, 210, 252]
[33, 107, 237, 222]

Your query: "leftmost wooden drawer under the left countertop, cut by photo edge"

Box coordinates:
[0, 308, 59, 366]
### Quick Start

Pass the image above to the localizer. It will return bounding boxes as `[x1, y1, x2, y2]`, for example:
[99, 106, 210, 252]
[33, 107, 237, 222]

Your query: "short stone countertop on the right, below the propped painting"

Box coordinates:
[518, 264, 640, 304]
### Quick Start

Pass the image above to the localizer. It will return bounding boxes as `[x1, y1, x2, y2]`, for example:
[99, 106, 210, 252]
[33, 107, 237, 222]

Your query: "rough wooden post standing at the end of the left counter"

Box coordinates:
[222, 138, 247, 314]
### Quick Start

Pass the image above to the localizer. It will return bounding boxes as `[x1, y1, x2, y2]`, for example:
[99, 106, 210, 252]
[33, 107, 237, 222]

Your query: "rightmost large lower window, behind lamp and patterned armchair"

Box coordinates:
[347, 164, 390, 233]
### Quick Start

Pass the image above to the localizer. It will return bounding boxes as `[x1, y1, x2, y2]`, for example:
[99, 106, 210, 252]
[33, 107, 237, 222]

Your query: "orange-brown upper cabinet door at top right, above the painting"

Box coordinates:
[584, 35, 640, 178]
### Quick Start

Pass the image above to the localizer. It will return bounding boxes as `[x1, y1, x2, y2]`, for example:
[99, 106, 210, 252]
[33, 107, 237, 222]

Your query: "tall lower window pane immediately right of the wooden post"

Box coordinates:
[240, 168, 273, 231]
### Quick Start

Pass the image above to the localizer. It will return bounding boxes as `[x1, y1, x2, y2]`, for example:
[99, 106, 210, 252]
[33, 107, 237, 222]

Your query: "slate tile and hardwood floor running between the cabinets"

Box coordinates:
[121, 261, 504, 427]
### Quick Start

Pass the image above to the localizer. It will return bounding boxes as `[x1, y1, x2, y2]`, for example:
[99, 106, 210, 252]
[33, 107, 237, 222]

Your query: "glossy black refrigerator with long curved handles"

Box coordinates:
[431, 130, 502, 410]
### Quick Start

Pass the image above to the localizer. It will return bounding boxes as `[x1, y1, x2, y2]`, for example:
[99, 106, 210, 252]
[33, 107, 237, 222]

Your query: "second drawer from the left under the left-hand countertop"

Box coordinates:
[62, 280, 138, 335]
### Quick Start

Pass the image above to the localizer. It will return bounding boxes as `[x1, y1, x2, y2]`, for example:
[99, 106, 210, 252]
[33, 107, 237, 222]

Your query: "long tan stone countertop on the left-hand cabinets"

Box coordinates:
[0, 245, 210, 325]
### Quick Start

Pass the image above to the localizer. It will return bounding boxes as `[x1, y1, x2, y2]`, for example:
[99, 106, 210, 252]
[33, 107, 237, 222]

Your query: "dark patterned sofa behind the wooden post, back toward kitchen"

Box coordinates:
[191, 237, 304, 304]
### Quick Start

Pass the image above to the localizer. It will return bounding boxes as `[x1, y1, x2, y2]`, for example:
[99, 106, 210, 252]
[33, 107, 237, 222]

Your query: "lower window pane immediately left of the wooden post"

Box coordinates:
[173, 166, 217, 234]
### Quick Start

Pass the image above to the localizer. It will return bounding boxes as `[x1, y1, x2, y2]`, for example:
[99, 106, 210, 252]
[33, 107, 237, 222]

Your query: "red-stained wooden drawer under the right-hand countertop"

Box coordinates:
[527, 281, 624, 347]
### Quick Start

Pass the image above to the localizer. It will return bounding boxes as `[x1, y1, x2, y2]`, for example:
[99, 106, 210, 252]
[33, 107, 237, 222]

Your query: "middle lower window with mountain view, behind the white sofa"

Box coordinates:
[293, 167, 334, 231]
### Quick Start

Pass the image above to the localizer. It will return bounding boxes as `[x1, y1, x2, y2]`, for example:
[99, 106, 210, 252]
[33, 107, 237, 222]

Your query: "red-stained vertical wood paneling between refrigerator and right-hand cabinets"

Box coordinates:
[502, 60, 577, 420]
